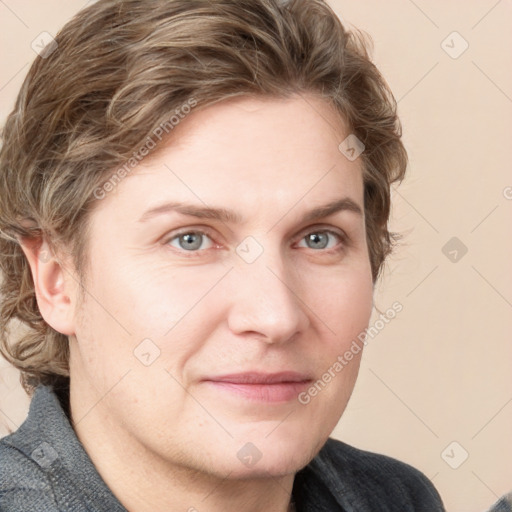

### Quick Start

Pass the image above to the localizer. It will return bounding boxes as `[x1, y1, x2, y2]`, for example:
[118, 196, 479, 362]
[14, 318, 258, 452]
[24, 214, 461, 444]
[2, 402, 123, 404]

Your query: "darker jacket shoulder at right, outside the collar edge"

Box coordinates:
[298, 438, 444, 512]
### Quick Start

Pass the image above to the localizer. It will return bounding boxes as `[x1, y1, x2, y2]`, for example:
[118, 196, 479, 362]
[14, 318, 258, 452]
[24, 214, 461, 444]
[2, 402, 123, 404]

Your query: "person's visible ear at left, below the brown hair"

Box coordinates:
[19, 238, 78, 336]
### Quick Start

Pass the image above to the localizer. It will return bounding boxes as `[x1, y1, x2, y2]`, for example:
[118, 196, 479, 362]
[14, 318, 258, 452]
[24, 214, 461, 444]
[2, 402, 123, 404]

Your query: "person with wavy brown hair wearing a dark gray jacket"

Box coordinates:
[0, 0, 443, 512]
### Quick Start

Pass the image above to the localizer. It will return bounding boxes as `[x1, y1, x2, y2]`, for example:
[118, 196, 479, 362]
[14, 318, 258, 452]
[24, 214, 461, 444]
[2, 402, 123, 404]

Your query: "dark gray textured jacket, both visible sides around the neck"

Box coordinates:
[0, 386, 444, 512]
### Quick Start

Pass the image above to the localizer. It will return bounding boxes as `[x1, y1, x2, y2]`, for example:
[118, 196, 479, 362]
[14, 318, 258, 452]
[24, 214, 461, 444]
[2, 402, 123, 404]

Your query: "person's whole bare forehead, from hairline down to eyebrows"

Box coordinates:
[93, 95, 362, 222]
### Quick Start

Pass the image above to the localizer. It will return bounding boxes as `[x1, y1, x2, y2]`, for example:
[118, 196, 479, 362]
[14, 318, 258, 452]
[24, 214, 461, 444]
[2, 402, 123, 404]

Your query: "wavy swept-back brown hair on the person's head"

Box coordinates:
[0, 0, 407, 390]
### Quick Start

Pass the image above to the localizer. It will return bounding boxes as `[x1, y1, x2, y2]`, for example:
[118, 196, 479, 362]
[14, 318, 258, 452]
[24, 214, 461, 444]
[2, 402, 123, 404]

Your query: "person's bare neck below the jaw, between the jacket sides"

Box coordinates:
[70, 378, 294, 512]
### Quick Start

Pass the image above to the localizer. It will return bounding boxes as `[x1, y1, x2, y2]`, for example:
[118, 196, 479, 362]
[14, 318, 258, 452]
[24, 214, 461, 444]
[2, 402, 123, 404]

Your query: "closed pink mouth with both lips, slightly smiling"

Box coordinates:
[203, 372, 313, 402]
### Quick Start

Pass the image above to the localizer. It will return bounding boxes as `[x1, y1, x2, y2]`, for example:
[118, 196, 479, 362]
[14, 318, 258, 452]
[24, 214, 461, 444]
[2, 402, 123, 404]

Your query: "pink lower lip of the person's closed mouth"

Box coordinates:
[206, 380, 310, 402]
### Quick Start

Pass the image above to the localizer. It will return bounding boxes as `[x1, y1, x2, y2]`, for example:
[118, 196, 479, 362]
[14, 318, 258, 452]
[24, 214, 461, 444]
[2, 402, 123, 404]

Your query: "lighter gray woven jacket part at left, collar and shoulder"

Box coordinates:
[0, 386, 125, 512]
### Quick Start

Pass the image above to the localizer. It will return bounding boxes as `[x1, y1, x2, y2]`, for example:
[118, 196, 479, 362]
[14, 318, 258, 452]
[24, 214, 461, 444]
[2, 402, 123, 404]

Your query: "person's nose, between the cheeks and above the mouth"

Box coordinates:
[228, 251, 309, 343]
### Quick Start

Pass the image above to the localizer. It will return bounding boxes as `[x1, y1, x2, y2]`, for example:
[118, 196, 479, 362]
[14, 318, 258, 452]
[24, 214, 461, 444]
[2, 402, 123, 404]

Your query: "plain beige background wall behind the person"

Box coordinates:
[0, 0, 512, 512]
